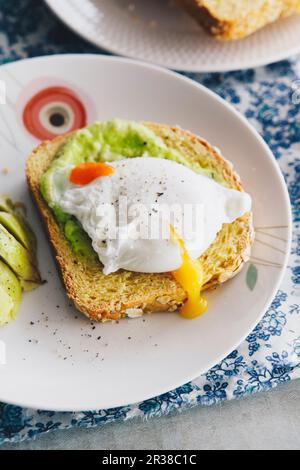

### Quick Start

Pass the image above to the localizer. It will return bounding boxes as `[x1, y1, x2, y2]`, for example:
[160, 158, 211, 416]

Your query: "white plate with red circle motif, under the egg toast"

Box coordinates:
[0, 56, 290, 411]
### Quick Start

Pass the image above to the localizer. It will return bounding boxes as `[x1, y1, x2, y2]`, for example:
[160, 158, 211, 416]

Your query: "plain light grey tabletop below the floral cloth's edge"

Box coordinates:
[1, 380, 300, 450]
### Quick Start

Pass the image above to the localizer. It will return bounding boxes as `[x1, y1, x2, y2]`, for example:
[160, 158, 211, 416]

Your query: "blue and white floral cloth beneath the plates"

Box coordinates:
[0, 0, 300, 444]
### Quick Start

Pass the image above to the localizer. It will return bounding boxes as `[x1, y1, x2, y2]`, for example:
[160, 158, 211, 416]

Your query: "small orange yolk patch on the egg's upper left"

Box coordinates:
[70, 162, 115, 186]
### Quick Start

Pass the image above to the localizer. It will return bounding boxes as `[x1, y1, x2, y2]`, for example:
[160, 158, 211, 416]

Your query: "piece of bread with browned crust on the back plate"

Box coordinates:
[177, 0, 300, 40]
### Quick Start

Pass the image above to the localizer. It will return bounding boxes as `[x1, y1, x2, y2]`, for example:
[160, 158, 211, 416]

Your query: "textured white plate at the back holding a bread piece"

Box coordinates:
[46, 0, 300, 72]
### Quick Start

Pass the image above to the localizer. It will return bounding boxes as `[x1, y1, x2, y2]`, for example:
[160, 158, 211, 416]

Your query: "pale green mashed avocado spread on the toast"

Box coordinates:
[40, 120, 214, 259]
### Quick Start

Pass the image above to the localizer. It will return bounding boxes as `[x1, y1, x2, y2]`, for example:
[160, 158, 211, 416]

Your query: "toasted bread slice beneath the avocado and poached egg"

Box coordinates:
[26, 123, 254, 321]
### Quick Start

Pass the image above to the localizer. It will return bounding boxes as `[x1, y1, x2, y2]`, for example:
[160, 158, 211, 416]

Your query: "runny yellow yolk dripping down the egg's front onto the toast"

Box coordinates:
[170, 226, 208, 319]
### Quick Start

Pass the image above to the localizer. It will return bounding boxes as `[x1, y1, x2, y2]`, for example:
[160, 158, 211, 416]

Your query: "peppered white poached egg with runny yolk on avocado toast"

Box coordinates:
[55, 157, 251, 318]
